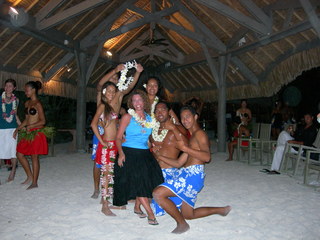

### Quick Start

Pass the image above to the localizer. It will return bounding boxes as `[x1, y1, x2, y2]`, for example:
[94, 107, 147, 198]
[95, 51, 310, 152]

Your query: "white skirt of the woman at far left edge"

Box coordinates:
[0, 128, 18, 159]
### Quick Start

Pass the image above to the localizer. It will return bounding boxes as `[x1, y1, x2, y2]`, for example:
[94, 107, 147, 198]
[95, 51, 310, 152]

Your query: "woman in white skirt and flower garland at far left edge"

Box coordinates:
[0, 79, 20, 182]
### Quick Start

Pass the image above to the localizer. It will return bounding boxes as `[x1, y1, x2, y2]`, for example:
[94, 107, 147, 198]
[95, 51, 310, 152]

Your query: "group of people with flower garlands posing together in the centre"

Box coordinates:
[91, 63, 231, 233]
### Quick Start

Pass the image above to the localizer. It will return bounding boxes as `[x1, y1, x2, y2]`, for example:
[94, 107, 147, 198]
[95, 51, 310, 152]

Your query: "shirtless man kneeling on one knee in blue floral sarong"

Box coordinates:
[153, 106, 231, 233]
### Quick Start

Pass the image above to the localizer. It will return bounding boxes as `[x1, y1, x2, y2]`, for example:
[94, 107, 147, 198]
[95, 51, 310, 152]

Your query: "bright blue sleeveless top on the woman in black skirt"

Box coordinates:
[122, 114, 152, 149]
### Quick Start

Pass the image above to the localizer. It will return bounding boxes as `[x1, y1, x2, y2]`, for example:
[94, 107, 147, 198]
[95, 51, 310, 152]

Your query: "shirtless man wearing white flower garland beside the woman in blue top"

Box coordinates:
[150, 102, 187, 216]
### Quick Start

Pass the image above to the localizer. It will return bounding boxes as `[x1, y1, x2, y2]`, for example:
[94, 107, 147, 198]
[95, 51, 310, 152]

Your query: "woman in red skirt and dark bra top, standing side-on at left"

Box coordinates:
[15, 81, 48, 189]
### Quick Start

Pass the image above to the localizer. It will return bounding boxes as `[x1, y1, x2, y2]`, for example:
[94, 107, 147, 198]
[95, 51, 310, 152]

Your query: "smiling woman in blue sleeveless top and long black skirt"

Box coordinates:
[113, 90, 163, 225]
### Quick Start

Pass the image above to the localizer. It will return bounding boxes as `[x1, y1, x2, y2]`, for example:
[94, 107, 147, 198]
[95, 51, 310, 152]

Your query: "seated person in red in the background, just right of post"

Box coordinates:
[226, 116, 250, 161]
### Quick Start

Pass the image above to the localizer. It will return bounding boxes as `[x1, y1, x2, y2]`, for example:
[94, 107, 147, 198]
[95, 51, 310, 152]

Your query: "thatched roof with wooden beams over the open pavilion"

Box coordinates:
[0, 0, 320, 101]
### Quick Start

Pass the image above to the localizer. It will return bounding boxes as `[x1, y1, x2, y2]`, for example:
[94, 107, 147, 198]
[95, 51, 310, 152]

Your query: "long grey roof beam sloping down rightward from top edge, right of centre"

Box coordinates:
[195, 0, 271, 35]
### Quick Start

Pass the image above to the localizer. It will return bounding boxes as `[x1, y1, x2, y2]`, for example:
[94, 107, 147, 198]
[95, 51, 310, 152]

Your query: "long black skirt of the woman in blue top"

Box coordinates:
[113, 147, 164, 206]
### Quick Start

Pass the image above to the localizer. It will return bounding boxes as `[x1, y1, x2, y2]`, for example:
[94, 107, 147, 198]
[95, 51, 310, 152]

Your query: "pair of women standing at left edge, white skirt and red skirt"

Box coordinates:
[0, 79, 48, 189]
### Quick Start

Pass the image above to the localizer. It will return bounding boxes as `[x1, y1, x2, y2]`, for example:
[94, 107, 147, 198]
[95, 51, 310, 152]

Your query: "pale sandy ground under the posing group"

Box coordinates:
[0, 142, 320, 240]
